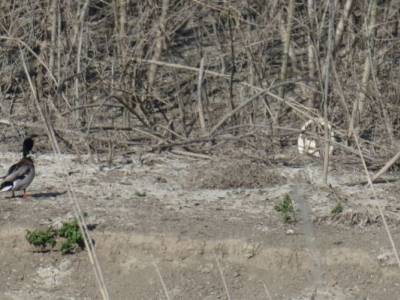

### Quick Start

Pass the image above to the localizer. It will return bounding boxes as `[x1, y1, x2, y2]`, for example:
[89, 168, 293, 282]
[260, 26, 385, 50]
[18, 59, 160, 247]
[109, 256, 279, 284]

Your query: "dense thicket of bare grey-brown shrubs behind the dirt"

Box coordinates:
[0, 0, 400, 159]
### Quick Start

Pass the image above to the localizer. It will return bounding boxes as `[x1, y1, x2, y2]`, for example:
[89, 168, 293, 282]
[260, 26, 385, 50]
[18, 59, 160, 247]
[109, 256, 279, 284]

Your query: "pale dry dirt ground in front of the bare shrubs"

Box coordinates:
[0, 148, 400, 300]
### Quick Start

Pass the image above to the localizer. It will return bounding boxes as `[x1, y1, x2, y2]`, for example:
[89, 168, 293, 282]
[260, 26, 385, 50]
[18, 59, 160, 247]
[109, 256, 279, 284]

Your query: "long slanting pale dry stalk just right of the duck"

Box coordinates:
[19, 48, 110, 300]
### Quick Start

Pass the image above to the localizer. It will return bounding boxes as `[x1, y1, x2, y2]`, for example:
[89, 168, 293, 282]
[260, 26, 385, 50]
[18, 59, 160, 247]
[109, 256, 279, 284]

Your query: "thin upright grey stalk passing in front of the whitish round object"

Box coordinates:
[323, 0, 335, 184]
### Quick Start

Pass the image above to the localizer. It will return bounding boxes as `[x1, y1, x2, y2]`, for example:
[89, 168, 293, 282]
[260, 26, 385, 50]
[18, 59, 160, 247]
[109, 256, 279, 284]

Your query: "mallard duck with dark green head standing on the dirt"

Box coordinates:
[0, 137, 35, 197]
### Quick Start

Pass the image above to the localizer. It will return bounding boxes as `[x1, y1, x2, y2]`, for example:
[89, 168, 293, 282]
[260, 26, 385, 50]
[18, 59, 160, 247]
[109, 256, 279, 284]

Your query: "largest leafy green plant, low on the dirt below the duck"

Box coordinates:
[25, 220, 85, 254]
